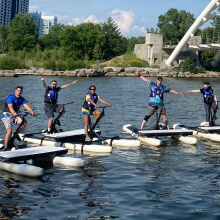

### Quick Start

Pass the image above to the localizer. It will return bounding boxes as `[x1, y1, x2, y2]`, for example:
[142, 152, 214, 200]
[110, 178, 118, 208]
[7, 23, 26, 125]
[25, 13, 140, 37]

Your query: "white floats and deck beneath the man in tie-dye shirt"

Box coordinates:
[123, 124, 197, 146]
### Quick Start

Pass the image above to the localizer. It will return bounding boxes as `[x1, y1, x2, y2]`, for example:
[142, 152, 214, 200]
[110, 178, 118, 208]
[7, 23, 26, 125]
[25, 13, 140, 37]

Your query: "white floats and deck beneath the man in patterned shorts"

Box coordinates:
[0, 146, 85, 177]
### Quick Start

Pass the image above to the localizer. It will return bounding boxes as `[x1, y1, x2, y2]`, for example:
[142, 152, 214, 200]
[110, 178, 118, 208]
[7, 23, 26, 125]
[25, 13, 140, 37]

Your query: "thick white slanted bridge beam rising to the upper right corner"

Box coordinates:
[165, 0, 220, 66]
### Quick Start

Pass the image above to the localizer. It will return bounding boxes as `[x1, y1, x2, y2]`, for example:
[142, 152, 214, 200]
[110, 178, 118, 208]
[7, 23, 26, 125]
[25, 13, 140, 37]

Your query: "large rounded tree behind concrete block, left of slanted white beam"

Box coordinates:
[157, 8, 195, 42]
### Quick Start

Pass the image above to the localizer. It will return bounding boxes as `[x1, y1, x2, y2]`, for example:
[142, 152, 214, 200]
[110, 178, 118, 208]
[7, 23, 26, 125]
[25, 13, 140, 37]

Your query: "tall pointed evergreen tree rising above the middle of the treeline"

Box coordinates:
[101, 17, 127, 59]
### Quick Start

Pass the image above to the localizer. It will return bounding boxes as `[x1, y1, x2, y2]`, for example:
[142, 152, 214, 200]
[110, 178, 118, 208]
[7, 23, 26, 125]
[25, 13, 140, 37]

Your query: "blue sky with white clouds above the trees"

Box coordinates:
[29, 0, 218, 38]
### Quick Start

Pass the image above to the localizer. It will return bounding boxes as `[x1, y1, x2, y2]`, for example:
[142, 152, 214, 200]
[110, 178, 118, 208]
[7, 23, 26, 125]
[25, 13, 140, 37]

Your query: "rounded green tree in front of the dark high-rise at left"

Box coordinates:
[6, 13, 38, 51]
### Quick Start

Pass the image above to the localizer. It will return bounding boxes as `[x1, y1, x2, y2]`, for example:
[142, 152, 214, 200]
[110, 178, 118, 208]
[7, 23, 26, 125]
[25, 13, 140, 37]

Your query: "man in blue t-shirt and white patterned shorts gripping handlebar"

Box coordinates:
[2, 86, 35, 151]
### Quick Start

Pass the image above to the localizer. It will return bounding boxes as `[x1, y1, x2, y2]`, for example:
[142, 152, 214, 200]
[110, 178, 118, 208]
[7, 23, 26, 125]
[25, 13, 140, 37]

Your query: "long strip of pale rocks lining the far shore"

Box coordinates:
[0, 67, 220, 78]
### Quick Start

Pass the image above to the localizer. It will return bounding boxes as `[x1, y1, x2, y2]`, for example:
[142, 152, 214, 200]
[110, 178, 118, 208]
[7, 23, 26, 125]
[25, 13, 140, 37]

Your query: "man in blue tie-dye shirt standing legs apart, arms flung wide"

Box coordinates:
[134, 71, 184, 130]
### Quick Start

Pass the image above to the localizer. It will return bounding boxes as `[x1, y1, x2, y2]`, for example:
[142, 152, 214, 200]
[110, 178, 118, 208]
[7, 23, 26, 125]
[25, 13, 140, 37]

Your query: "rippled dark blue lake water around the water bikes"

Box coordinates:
[0, 76, 220, 220]
